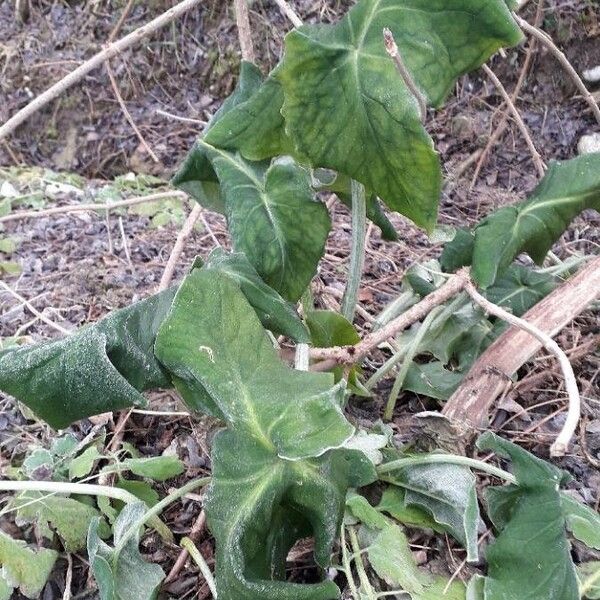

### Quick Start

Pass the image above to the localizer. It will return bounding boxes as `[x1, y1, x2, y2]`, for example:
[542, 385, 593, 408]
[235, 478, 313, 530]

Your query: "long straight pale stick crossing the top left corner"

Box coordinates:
[0, 0, 201, 140]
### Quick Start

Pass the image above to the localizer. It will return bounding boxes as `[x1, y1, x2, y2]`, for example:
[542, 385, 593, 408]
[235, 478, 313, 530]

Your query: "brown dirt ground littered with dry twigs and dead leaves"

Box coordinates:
[0, 0, 600, 599]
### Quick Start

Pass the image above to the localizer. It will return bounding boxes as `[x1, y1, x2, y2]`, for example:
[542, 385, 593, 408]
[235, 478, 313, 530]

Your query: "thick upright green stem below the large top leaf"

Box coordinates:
[342, 180, 367, 322]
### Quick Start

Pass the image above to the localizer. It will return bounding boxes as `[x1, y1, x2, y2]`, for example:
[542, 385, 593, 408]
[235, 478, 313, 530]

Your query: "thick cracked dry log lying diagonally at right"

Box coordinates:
[443, 257, 600, 427]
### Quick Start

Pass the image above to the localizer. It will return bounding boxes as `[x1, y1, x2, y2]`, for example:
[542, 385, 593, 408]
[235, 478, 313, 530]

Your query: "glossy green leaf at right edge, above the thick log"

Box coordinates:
[444, 154, 600, 288]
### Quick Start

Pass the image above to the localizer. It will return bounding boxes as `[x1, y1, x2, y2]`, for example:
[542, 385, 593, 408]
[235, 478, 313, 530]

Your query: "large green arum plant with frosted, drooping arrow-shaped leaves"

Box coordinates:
[0, 0, 600, 600]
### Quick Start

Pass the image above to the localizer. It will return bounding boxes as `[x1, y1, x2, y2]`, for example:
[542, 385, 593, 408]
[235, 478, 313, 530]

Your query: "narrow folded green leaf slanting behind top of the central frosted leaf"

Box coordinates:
[204, 248, 310, 343]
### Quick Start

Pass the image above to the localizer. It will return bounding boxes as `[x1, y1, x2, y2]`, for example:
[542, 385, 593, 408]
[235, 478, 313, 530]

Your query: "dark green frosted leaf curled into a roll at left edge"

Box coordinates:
[0, 289, 175, 428]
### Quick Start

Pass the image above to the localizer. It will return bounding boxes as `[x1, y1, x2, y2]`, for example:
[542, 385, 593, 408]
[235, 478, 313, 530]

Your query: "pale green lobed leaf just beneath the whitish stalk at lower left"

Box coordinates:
[11, 491, 109, 552]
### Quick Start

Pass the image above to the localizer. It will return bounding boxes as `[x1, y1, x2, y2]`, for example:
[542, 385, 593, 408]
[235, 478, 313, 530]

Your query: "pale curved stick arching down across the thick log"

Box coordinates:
[465, 281, 581, 457]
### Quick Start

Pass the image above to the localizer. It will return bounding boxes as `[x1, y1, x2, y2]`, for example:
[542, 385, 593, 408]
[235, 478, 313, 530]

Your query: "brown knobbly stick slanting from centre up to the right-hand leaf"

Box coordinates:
[310, 269, 470, 371]
